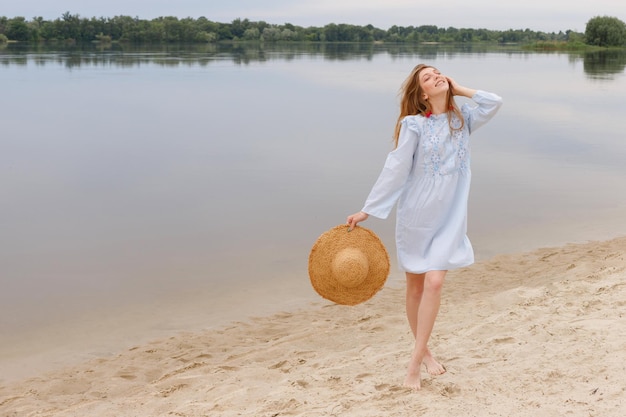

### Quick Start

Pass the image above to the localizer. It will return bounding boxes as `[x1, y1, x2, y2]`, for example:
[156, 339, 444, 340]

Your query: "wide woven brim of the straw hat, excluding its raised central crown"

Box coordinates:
[309, 225, 389, 305]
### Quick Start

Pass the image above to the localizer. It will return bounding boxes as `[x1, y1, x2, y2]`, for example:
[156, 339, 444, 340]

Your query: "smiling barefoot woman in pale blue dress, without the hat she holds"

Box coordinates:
[347, 64, 502, 390]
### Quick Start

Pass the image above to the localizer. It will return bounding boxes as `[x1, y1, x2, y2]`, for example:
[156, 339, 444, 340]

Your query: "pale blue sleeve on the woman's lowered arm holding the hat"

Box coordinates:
[362, 118, 419, 219]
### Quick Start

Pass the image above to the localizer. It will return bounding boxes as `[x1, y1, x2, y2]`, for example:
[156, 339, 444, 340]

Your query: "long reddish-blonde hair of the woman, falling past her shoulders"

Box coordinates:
[393, 64, 465, 147]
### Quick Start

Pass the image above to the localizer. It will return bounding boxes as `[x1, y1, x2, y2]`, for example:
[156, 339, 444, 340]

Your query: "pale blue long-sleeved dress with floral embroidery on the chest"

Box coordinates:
[362, 91, 502, 273]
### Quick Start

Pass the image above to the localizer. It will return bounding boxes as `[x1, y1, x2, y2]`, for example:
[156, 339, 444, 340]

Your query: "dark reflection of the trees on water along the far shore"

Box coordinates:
[0, 42, 626, 80]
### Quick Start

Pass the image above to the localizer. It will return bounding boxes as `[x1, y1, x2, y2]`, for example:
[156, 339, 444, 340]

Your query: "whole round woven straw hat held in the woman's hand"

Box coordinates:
[309, 225, 389, 305]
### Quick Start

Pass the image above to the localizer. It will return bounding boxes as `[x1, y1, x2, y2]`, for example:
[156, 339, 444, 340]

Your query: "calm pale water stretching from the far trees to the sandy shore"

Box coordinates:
[0, 46, 626, 380]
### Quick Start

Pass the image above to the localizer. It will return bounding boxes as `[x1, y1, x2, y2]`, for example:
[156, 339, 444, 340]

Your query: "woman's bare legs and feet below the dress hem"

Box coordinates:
[404, 271, 447, 389]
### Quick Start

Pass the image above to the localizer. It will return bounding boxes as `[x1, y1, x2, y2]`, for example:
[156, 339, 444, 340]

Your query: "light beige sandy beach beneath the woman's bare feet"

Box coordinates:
[0, 237, 626, 417]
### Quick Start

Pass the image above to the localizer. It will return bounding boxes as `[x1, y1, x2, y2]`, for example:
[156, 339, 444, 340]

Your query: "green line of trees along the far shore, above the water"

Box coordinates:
[0, 12, 626, 47]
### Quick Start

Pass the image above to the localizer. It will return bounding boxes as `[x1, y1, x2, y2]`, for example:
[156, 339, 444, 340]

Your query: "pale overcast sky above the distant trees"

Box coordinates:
[0, 0, 626, 33]
